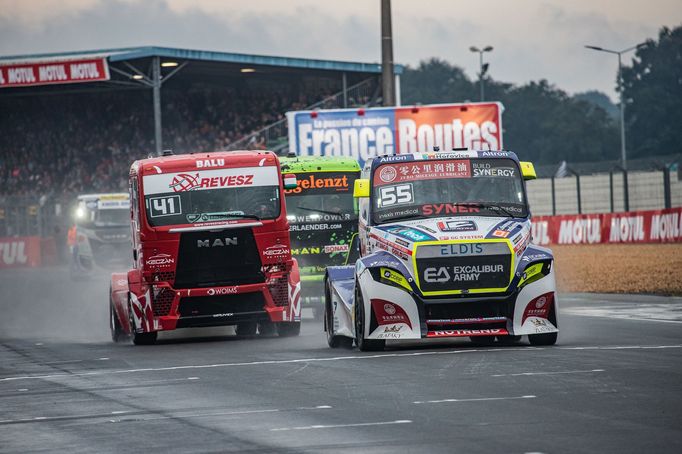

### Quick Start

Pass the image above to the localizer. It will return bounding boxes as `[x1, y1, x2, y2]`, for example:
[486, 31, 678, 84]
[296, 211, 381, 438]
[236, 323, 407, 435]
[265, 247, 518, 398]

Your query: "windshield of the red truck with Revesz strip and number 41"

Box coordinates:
[143, 167, 280, 227]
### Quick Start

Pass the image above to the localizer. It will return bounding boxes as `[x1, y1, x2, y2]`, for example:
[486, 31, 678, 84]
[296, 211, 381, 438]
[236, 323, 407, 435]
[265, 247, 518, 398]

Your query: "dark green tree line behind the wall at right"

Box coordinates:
[401, 26, 682, 164]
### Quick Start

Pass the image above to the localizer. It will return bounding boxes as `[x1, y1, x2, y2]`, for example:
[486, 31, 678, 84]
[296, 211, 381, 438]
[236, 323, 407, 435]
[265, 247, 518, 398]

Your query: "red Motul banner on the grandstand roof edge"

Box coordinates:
[0, 58, 109, 88]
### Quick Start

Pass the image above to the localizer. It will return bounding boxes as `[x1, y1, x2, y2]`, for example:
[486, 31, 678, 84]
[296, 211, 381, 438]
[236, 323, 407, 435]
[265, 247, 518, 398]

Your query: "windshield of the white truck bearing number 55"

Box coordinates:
[372, 158, 528, 224]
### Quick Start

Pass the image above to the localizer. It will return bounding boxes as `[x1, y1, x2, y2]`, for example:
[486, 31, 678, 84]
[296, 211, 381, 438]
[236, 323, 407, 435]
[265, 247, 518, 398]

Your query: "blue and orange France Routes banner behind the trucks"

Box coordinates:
[287, 102, 504, 165]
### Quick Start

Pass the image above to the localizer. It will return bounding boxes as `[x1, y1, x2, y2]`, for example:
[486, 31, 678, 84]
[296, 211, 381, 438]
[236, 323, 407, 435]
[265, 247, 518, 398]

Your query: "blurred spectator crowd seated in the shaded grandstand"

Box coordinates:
[0, 87, 322, 198]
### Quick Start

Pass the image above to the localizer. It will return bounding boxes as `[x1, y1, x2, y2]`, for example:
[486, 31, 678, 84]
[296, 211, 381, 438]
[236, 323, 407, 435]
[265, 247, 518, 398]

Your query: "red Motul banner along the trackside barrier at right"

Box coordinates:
[533, 207, 682, 245]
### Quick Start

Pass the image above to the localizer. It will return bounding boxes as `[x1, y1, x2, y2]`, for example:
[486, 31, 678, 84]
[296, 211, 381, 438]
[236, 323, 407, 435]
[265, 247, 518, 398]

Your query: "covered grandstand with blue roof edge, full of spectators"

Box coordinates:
[0, 47, 402, 200]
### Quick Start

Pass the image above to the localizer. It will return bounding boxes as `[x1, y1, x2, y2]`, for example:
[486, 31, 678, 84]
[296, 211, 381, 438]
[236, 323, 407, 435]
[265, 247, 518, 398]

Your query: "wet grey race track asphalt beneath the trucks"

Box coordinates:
[0, 268, 682, 453]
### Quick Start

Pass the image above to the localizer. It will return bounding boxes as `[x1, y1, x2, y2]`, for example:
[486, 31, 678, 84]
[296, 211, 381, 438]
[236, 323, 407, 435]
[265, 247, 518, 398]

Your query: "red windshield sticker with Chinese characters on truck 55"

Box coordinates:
[374, 160, 471, 186]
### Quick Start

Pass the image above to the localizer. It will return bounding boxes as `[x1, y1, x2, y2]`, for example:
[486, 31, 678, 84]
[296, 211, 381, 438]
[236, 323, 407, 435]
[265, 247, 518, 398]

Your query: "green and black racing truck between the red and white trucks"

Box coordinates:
[280, 156, 361, 319]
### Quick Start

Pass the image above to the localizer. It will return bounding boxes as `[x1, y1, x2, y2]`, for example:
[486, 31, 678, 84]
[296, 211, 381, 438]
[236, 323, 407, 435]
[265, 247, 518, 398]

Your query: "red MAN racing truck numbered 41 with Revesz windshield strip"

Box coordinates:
[110, 151, 301, 344]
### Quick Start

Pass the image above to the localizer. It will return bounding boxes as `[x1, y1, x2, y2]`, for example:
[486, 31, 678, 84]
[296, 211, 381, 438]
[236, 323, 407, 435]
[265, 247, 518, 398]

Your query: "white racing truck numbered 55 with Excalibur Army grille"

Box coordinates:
[325, 151, 559, 350]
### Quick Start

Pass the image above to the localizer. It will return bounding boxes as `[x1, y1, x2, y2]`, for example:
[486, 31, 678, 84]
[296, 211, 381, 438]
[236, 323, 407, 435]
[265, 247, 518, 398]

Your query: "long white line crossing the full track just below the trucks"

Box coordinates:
[0, 344, 682, 383]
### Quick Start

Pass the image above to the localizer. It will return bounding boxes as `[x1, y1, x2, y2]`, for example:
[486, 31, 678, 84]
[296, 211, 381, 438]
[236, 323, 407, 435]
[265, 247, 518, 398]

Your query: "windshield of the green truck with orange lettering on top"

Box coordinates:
[284, 172, 357, 224]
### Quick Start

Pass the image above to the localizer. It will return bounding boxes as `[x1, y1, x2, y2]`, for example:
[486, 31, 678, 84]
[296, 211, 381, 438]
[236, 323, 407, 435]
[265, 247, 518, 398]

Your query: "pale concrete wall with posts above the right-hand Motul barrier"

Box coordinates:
[527, 172, 682, 215]
